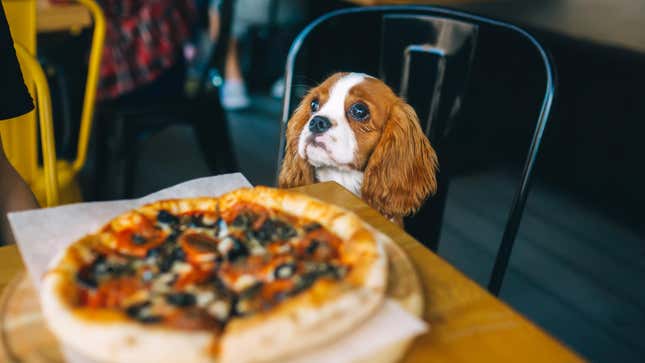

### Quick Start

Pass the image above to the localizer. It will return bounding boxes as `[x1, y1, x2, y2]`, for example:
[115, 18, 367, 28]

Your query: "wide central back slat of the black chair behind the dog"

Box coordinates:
[379, 14, 479, 252]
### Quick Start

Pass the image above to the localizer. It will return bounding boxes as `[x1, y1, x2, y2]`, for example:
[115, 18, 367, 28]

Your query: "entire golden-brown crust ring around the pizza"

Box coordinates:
[41, 187, 387, 363]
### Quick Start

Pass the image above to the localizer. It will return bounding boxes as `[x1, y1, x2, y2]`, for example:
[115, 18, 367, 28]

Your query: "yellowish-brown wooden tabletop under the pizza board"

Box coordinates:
[0, 182, 582, 363]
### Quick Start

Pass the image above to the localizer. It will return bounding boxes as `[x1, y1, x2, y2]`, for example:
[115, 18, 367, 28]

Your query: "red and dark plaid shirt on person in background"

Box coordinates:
[98, 0, 195, 99]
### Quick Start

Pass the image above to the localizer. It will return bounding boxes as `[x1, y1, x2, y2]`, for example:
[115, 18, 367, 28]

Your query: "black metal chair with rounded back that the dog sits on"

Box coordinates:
[278, 6, 555, 294]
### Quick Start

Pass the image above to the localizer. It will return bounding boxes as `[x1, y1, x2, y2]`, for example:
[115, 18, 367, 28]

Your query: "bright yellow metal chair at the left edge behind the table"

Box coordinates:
[3, 0, 105, 204]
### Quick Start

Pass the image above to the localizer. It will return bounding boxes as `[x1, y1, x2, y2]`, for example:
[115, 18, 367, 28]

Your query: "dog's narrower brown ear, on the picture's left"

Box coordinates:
[278, 101, 314, 188]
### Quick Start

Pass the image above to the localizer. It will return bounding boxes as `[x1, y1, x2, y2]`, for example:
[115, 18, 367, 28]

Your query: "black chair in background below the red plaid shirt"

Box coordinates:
[95, 0, 237, 199]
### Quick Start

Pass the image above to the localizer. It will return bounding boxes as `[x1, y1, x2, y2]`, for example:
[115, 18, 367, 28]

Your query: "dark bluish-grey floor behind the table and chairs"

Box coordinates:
[117, 92, 645, 362]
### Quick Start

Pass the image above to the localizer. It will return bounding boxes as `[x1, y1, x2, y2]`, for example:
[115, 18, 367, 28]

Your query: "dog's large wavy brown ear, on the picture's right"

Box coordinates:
[361, 101, 438, 218]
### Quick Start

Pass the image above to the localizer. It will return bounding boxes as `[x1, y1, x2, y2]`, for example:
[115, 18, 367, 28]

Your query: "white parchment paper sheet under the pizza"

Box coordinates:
[9, 173, 427, 363]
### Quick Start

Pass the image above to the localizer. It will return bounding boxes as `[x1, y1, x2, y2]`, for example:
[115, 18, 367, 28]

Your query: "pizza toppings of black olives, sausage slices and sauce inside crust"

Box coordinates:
[70, 203, 351, 329]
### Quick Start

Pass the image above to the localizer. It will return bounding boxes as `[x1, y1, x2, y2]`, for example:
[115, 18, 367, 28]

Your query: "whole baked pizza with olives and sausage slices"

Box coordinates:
[41, 187, 387, 362]
